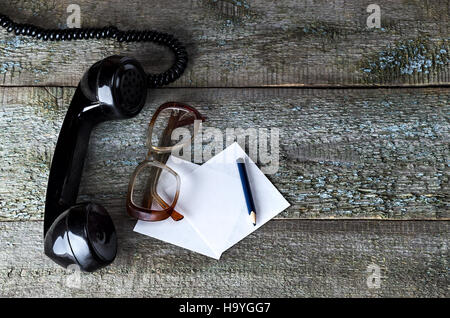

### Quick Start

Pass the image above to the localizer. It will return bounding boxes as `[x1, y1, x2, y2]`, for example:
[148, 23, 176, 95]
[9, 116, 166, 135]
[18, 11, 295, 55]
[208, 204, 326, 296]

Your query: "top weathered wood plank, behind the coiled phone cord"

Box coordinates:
[0, 0, 450, 87]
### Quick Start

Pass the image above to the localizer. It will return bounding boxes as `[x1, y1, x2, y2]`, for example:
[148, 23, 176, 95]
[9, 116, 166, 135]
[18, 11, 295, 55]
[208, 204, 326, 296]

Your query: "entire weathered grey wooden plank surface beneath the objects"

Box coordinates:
[0, 0, 450, 297]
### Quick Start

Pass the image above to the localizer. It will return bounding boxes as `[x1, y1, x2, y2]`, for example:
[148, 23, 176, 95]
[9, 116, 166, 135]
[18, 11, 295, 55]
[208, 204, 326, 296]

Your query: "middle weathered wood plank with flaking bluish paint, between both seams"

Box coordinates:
[0, 87, 450, 220]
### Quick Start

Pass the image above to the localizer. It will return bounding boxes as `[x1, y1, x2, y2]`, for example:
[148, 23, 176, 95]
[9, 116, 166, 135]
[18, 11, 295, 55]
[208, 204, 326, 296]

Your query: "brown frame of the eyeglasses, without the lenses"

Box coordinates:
[126, 102, 206, 221]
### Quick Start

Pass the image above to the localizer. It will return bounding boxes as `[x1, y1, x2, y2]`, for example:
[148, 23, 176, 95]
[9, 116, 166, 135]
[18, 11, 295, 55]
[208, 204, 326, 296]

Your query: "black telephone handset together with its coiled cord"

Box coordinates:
[0, 14, 188, 272]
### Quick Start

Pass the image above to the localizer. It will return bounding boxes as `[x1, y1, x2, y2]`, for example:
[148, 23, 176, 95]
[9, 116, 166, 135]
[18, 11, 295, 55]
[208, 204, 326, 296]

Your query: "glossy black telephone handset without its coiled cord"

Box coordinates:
[44, 56, 147, 271]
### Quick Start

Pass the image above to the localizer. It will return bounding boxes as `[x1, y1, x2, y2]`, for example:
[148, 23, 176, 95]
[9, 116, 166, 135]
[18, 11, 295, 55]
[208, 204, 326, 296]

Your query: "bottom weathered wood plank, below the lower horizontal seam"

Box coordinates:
[0, 220, 450, 297]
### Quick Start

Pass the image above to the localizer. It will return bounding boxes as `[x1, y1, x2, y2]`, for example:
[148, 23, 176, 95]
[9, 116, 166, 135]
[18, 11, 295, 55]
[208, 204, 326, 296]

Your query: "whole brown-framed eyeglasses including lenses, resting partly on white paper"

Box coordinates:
[126, 102, 206, 221]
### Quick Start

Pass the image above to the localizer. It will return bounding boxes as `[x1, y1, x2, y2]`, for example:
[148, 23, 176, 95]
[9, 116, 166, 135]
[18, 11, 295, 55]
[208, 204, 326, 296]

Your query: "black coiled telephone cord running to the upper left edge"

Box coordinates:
[0, 14, 188, 87]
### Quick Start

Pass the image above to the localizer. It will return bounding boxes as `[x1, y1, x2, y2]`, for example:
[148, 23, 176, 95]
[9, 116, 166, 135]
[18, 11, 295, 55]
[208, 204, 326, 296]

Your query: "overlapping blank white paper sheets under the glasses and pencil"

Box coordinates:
[134, 143, 289, 259]
